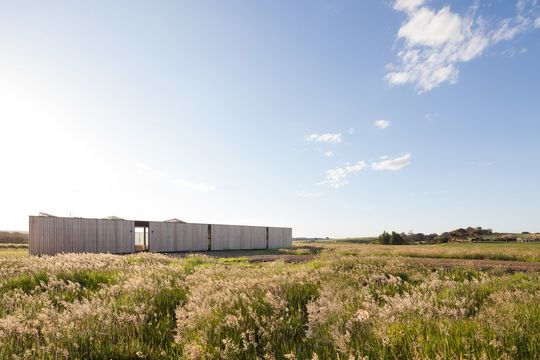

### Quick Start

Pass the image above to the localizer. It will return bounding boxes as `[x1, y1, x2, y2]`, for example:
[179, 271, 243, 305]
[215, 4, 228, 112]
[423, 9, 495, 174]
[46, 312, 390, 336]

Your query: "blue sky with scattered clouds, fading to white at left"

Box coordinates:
[0, 0, 540, 237]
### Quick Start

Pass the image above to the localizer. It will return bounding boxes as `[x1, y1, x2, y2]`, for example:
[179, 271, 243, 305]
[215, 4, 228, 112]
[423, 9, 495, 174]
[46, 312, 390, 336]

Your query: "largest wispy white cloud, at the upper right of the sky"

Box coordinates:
[385, 0, 540, 93]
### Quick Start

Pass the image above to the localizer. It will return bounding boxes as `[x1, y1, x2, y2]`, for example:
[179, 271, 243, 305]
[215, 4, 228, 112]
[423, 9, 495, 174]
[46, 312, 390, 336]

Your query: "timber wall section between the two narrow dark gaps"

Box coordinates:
[211, 225, 266, 250]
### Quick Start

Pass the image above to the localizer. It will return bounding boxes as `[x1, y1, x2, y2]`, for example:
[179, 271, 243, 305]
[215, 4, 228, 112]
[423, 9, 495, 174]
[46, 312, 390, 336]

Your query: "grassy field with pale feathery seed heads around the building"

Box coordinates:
[0, 241, 540, 359]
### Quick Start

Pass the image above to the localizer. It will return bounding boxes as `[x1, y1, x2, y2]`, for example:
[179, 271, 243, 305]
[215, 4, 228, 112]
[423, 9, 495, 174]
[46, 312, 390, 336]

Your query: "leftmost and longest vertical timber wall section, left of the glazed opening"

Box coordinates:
[29, 216, 135, 255]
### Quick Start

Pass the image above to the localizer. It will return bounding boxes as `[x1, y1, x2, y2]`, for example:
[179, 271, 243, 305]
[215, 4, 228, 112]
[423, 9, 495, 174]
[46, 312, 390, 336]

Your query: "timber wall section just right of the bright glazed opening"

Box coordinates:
[148, 221, 208, 252]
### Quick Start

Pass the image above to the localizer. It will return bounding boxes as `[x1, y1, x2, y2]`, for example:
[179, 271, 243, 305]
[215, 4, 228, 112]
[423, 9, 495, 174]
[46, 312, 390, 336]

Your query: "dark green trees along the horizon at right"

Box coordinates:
[377, 227, 493, 245]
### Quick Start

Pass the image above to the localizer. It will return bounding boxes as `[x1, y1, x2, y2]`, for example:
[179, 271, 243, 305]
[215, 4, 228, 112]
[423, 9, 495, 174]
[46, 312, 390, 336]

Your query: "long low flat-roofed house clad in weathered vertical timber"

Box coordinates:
[29, 216, 292, 255]
